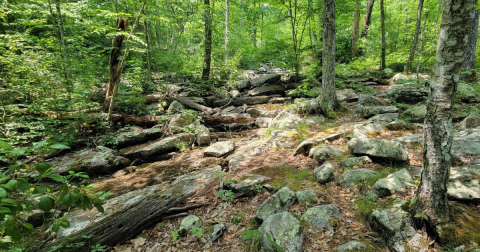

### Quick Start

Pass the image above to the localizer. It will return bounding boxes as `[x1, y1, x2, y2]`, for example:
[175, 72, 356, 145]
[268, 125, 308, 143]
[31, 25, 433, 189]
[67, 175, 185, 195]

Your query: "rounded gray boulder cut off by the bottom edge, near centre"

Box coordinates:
[258, 212, 304, 252]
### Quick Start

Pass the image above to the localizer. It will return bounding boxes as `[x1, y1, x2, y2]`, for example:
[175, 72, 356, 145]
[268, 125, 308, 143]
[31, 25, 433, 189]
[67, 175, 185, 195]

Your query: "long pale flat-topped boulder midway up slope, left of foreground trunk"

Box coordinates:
[348, 138, 408, 162]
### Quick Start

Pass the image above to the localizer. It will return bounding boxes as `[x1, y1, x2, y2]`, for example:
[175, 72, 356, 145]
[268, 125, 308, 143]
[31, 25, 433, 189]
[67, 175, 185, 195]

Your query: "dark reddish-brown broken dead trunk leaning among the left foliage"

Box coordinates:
[103, 17, 128, 110]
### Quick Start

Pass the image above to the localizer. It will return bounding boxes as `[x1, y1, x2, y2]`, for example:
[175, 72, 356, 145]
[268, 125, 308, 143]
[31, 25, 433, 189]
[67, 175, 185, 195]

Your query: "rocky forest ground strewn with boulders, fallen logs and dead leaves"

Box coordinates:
[21, 69, 480, 252]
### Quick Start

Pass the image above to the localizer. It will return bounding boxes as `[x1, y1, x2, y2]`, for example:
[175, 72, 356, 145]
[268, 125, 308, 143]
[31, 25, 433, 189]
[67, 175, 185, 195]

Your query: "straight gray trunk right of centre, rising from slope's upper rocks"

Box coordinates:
[321, 0, 338, 115]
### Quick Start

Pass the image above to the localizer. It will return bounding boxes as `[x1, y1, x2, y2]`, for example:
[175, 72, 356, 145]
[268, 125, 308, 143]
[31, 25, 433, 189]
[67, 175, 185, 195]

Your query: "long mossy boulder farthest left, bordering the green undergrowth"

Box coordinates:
[48, 146, 130, 176]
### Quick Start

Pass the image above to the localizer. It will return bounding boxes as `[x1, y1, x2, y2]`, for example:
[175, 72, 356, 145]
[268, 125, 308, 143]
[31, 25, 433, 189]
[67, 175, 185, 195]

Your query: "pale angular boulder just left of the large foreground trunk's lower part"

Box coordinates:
[371, 169, 413, 198]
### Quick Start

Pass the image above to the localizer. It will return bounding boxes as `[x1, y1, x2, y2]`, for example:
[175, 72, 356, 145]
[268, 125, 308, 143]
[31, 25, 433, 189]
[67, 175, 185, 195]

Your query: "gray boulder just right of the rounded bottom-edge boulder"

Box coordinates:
[302, 204, 343, 229]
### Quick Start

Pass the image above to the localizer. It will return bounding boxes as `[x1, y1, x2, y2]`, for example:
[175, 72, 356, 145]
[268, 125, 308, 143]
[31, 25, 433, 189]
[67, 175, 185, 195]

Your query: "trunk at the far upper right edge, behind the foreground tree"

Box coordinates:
[462, 0, 479, 82]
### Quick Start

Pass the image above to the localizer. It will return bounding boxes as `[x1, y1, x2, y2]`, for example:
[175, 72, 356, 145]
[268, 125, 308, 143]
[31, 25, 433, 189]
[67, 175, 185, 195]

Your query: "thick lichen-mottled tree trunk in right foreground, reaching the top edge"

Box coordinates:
[412, 0, 476, 231]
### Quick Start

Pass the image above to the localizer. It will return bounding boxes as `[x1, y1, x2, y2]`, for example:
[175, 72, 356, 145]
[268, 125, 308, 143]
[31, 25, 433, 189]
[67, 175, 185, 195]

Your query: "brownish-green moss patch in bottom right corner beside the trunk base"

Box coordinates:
[439, 202, 480, 248]
